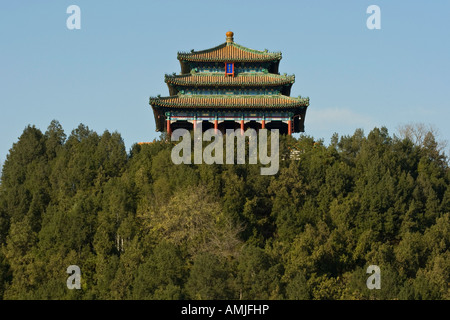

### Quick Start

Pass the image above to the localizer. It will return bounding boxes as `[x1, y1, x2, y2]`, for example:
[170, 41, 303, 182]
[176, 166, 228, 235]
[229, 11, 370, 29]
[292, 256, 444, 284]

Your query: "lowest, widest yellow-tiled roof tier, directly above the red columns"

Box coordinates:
[150, 94, 309, 109]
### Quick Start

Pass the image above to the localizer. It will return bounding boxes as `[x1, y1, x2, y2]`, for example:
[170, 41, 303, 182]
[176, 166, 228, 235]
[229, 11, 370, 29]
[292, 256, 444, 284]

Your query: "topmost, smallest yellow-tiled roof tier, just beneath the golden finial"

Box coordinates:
[177, 42, 281, 62]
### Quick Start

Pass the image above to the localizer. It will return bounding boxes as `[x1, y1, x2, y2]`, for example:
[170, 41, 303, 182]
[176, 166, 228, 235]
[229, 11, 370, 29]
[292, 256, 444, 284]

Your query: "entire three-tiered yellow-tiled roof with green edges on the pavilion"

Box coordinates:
[150, 32, 309, 131]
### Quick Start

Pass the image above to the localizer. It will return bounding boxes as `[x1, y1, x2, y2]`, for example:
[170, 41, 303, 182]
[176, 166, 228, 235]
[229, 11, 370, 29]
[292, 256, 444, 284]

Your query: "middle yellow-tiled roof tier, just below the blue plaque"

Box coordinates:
[164, 72, 295, 87]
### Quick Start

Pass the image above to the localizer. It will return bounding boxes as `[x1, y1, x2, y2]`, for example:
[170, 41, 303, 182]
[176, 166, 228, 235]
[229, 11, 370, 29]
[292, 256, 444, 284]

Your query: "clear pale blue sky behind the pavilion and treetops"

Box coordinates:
[0, 0, 450, 168]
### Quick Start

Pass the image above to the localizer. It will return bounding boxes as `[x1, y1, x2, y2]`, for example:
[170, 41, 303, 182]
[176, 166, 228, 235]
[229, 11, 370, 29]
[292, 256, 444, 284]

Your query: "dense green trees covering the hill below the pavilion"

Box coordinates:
[0, 121, 450, 299]
